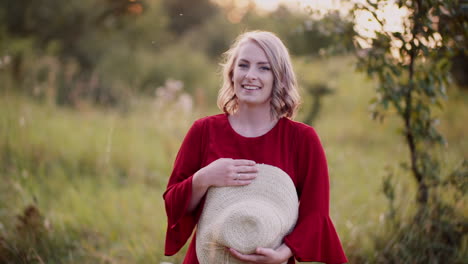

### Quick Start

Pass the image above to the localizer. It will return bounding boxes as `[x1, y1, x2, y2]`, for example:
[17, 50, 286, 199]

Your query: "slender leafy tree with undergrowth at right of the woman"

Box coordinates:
[355, 0, 468, 263]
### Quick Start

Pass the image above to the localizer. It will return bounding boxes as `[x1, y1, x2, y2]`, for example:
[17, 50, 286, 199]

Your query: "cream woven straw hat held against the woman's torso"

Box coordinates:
[196, 164, 299, 264]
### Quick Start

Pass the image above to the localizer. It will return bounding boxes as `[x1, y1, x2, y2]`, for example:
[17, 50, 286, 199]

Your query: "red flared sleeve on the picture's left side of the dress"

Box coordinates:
[163, 120, 203, 256]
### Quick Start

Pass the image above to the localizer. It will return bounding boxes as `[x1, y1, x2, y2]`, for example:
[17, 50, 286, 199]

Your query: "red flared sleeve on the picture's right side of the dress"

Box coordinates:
[284, 126, 348, 264]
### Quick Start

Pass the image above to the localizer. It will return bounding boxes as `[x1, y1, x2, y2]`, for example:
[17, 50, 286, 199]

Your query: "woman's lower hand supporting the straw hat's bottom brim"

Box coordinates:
[229, 244, 292, 264]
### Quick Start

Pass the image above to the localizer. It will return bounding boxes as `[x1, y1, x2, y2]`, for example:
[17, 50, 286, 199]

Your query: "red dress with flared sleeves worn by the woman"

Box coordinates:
[163, 114, 347, 264]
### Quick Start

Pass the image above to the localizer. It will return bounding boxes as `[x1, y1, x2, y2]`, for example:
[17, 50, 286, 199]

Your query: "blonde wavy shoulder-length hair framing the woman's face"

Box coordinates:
[218, 31, 300, 118]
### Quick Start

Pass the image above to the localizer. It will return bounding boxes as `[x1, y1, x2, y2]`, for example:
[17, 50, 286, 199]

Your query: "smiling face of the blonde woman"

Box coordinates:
[232, 41, 274, 106]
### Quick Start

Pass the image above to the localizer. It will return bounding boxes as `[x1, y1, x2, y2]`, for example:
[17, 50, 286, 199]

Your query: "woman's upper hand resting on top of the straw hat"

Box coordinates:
[195, 158, 258, 187]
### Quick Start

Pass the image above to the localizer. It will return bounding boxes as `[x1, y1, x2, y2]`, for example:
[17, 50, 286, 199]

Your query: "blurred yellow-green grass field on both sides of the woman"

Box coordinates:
[0, 57, 468, 263]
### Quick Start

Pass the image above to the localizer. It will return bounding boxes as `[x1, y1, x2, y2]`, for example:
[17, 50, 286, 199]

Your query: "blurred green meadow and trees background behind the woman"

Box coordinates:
[0, 0, 468, 263]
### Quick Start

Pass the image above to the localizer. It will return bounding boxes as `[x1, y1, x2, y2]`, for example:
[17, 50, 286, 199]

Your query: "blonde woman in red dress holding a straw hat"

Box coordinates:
[164, 31, 347, 264]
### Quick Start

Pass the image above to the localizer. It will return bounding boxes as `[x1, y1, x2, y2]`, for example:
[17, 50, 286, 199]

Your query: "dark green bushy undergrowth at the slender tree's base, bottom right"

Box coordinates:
[370, 161, 468, 264]
